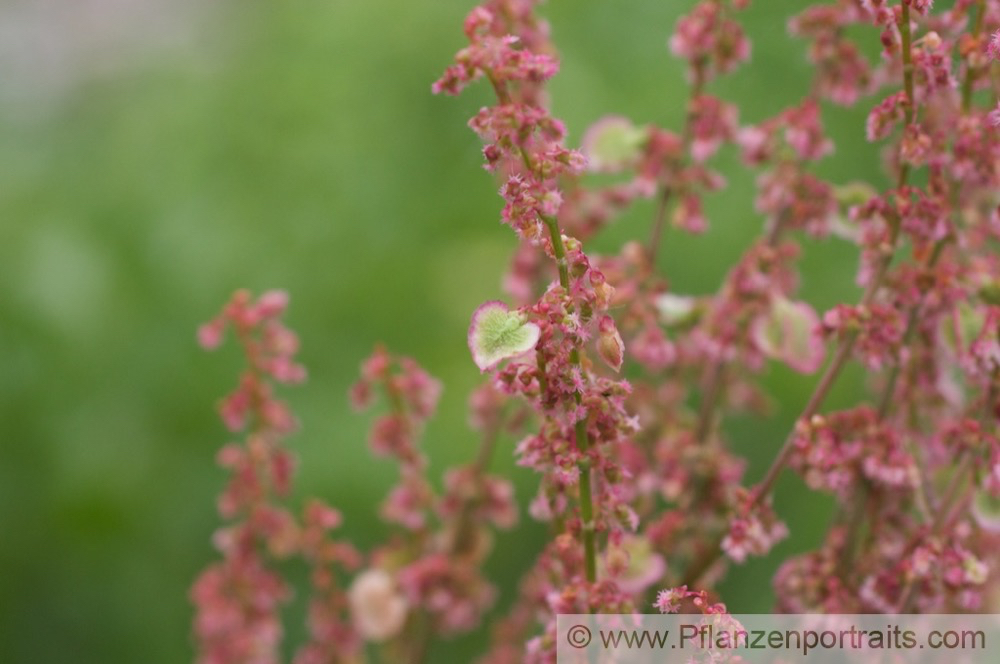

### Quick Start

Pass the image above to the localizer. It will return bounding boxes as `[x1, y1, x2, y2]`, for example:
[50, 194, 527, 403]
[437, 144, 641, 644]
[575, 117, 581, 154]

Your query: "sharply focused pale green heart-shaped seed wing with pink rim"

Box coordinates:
[469, 300, 541, 372]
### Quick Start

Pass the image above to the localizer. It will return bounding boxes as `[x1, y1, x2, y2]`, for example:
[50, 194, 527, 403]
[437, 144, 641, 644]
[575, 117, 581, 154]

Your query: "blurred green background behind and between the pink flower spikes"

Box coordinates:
[0, 0, 882, 664]
